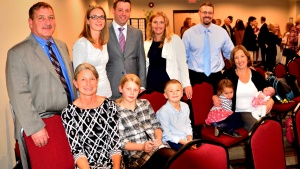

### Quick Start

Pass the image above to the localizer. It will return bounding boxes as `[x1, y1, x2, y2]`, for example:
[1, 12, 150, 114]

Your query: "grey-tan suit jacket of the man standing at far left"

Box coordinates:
[6, 34, 75, 139]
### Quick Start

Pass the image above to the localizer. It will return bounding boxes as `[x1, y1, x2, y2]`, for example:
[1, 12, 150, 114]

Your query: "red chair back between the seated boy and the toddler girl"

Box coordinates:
[191, 82, 214, 127]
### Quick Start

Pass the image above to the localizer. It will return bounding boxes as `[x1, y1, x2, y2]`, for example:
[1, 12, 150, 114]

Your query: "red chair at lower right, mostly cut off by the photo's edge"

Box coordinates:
[292, 103, 300, 168]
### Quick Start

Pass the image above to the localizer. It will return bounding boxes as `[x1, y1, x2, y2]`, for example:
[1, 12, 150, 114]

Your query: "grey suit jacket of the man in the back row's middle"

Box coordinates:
[107, 24, 146, 99]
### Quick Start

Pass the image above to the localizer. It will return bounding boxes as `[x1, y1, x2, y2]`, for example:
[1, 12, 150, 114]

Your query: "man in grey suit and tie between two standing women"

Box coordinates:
[106, 0, 146, 99]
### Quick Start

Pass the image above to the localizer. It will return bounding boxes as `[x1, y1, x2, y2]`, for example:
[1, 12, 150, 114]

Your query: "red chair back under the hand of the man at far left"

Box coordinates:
[23, 115, 74, 169]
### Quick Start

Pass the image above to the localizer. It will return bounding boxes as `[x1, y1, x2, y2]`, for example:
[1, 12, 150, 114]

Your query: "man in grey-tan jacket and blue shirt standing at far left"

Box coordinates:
[6, 2, 76, 169]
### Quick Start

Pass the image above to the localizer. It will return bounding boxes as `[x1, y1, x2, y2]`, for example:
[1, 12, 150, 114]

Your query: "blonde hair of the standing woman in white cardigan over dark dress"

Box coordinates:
[146, 11, 173, 48]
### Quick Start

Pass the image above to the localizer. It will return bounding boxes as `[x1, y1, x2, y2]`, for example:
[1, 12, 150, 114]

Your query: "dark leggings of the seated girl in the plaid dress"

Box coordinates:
[141, 148, 176, 169]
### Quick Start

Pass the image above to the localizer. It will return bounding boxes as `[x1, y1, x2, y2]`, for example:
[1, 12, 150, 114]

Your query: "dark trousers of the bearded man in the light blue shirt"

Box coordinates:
[189, 69, 223, 93]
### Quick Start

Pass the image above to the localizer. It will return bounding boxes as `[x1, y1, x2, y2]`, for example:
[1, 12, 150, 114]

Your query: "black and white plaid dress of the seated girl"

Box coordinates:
[118, 99, 168, 169]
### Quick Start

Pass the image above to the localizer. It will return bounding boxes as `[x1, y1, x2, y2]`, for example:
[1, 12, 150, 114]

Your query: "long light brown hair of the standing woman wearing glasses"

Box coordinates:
[79, 5, 109, 45]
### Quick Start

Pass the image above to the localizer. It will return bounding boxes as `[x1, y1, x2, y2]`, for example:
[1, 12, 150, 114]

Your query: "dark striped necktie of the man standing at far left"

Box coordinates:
[47, 41, 71, 103]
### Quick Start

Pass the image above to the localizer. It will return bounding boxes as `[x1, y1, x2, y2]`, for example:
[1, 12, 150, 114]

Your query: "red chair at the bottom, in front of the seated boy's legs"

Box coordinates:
[166, 139, 229, 169]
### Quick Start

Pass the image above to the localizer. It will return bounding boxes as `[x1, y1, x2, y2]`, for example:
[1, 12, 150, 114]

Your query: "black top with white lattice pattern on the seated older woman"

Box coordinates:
[61, 99, 122, 168]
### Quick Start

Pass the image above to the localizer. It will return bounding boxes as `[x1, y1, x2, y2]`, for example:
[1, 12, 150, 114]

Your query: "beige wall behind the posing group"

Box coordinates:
[0, 0, 299, 169]
